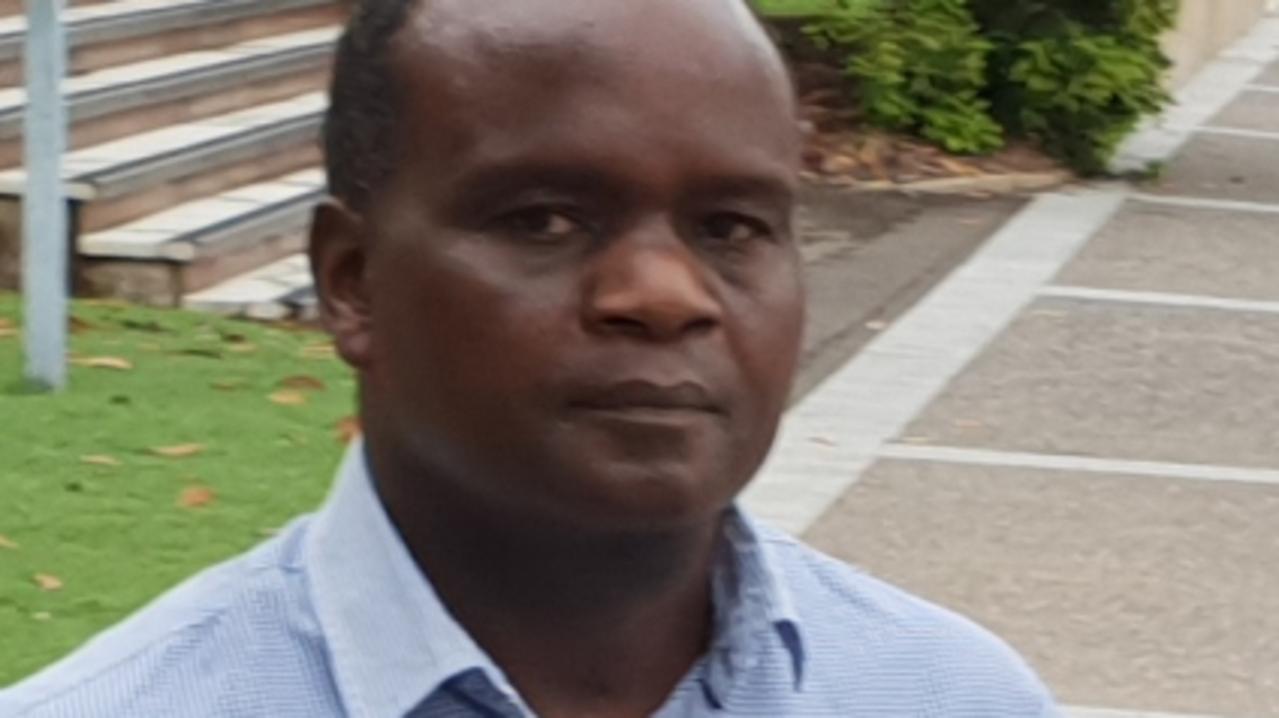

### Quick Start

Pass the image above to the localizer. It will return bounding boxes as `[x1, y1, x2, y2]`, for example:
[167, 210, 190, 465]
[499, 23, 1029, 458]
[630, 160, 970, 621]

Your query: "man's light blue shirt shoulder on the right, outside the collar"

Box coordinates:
[761, 530, 1058, 718]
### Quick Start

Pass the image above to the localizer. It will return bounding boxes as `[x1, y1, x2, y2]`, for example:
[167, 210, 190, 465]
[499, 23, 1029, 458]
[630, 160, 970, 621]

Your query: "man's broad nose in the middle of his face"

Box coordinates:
[583, 226, 723, 342]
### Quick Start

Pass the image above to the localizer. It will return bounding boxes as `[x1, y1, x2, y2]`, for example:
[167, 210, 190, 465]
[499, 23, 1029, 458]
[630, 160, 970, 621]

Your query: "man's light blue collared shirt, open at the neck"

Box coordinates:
[0, 445, 1059, 718]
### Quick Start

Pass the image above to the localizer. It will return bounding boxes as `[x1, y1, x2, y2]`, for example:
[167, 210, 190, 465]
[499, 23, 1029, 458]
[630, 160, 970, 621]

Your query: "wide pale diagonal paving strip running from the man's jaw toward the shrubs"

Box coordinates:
[743, 188, 1126, 534]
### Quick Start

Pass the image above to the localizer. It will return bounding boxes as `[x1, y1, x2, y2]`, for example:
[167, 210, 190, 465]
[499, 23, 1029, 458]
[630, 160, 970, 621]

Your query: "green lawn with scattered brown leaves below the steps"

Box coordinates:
[0, 294, 354, 686]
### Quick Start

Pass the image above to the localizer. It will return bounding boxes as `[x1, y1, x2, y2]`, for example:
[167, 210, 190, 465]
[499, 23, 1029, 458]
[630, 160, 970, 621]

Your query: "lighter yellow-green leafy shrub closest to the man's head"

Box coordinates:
[807, 0, 1003, 154]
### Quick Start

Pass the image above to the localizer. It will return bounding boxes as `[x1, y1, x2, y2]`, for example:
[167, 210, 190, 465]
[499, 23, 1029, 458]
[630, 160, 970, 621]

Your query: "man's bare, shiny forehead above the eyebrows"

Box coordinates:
[383, 0, 797, 193]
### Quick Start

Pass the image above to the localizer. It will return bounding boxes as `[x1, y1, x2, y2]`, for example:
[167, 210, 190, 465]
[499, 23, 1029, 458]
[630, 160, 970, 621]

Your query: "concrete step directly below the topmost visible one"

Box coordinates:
[0, 24, 339, 168]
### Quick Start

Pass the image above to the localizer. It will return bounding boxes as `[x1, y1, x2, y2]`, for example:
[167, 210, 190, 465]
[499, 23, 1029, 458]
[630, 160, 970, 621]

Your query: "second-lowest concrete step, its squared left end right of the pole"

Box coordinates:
[77, 168, 324, 306]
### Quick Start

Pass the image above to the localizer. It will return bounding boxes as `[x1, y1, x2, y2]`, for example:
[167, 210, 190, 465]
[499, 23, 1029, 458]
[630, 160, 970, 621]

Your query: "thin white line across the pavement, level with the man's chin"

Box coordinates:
[879, 444, 1279, 485]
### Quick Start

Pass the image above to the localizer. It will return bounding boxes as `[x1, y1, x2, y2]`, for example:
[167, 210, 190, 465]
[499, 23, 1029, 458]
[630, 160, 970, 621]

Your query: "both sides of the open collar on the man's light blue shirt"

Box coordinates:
[306, 440, 804, 718]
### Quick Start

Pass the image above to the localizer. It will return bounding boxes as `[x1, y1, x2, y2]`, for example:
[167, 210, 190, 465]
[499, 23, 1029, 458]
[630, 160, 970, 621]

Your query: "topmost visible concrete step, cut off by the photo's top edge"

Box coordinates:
[0, 0, 341, 87]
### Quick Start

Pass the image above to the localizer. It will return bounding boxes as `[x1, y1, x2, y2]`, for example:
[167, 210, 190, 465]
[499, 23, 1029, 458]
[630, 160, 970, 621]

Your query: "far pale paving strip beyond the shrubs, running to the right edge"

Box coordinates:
[1113, 18, 1279, 172]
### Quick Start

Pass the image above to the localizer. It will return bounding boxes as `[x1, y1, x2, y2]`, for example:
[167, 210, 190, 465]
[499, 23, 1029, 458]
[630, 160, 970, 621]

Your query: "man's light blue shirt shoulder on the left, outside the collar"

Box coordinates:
[0, 520, 335, 718]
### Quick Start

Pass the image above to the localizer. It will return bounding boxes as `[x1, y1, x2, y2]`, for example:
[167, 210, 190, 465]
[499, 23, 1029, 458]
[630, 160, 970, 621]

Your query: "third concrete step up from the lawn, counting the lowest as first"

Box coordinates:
[0, 92, 326, 232]
